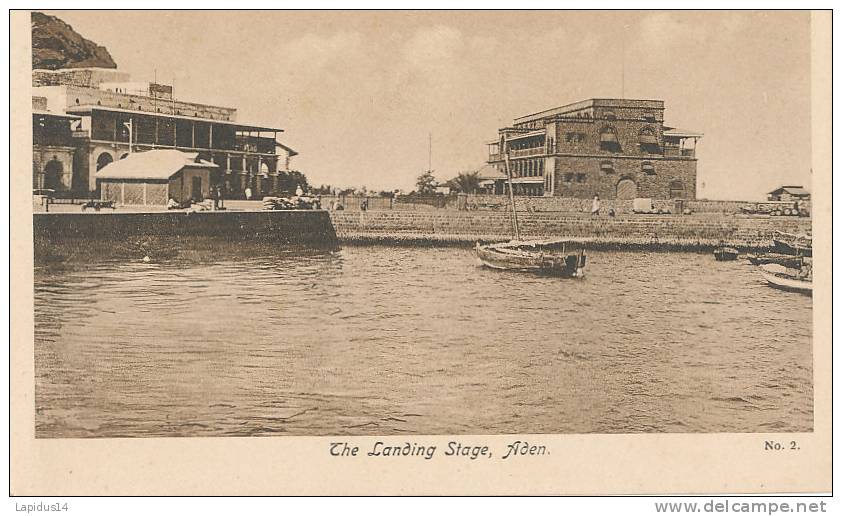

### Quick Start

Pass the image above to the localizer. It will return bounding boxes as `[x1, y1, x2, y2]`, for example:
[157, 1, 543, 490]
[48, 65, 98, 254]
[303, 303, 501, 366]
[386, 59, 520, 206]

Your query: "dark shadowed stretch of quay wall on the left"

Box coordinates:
[33, 210, 337, 248]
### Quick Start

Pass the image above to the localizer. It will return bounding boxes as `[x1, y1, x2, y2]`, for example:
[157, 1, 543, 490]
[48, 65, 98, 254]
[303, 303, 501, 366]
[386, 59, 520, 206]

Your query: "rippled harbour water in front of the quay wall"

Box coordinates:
[35, 241, 813, 437]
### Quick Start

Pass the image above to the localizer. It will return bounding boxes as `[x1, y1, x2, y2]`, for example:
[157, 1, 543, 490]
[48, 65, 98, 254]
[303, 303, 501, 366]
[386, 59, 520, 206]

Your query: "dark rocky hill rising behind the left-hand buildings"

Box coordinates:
[32, 12, 117, 70]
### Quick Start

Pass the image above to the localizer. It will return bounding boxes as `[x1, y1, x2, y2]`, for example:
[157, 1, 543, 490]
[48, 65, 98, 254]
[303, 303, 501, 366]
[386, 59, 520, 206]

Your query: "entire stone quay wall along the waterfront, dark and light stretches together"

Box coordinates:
[33, 210, 812, 252]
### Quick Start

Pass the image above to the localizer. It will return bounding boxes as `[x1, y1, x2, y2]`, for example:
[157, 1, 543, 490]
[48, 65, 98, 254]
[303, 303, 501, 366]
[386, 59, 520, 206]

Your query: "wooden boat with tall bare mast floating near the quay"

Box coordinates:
[476, 135, 586, 278]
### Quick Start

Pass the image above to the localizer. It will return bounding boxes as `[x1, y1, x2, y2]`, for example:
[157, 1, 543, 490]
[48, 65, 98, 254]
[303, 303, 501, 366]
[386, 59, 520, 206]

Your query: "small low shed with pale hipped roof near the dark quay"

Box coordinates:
[96, 149, 219, 206]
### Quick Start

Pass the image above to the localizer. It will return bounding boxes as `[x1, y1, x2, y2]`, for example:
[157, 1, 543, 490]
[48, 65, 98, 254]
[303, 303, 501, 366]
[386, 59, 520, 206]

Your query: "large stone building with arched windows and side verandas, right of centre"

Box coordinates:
[488, 99, 702, 199]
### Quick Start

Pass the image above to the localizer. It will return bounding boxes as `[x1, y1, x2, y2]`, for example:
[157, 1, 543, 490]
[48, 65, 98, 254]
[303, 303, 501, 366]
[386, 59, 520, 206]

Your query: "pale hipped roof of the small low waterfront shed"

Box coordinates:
[96, 149, 218, 179]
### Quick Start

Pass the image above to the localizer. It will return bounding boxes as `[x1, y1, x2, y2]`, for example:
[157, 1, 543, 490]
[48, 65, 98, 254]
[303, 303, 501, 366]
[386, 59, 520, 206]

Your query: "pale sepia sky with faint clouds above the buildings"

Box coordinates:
[48, 11, 811, 200]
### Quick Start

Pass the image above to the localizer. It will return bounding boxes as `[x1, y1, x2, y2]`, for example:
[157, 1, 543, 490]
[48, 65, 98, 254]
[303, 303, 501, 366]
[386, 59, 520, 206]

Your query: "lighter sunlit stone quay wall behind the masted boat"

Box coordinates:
[330, 210, 812, 251]
